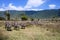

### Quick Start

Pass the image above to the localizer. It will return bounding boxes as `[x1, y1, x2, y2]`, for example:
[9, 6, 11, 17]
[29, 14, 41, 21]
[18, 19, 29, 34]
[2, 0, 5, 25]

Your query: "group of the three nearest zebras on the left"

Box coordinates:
[5, 21, 26, 31]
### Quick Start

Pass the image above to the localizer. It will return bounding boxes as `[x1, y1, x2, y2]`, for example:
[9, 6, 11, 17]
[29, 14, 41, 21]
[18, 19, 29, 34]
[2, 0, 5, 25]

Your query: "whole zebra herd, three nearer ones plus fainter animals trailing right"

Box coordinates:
[5, 21, 41, 31]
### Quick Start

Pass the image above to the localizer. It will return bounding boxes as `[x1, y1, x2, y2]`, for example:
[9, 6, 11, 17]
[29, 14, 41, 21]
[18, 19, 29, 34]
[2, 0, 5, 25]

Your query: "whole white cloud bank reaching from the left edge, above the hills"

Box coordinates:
[0, 3, 23, 11]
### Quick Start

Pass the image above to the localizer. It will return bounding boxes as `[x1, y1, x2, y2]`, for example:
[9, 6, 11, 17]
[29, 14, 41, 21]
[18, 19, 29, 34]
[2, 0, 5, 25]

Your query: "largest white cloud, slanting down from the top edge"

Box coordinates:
[25, 0, 46, 8]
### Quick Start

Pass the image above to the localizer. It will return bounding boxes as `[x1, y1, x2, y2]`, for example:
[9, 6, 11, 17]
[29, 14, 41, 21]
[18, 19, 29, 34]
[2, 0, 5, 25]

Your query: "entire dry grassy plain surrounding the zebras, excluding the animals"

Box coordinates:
[0, 21, 60, 40]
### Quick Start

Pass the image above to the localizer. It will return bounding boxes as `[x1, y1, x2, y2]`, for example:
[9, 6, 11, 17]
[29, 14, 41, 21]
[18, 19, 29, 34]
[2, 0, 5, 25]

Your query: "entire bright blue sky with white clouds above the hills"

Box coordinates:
[0, 0, 60, 11]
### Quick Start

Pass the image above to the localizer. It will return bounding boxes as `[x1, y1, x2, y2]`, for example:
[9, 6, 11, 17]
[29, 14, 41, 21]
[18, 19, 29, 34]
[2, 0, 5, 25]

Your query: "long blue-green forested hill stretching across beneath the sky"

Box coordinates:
[0, 9, 60, 19]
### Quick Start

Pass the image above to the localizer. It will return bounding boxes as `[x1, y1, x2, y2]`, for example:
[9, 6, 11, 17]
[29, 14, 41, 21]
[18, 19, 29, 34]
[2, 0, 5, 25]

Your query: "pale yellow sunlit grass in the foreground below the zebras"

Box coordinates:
[0, 23, 60, 40]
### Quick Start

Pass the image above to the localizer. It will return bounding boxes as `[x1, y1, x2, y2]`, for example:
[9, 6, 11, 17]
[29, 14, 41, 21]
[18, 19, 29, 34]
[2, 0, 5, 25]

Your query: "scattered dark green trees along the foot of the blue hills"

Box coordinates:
[0, 10, 60, 21]
